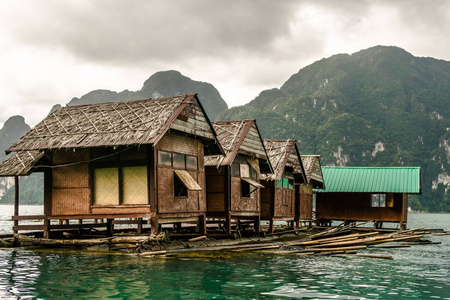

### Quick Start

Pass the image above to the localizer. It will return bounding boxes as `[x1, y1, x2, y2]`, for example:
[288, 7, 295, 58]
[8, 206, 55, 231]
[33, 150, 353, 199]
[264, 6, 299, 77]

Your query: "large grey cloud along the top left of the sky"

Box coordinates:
[8, 1, 297, 63]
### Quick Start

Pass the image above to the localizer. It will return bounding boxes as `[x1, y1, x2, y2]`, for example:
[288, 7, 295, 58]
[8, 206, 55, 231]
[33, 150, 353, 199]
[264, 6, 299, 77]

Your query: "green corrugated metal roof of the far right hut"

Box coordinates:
[315, 167, 421, 194]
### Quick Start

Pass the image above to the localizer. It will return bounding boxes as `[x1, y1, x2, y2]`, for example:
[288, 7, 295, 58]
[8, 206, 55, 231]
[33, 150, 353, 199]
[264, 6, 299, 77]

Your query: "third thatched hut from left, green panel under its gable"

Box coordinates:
[259, 140, 306, 233]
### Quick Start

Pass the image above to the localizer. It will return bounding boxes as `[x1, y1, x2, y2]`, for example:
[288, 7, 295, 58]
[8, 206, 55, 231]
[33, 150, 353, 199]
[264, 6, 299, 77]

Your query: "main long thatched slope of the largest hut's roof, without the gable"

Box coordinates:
[7, 95, 196, 153]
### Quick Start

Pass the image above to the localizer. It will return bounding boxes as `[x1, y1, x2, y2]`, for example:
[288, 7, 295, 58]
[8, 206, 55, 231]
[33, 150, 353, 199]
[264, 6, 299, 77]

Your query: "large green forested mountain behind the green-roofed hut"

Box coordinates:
[218, 46, 450, 212]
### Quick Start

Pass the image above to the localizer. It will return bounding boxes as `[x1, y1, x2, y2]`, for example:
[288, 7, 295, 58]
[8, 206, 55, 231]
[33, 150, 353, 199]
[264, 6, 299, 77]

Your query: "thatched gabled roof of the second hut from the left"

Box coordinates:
[205, 120, 271, 170]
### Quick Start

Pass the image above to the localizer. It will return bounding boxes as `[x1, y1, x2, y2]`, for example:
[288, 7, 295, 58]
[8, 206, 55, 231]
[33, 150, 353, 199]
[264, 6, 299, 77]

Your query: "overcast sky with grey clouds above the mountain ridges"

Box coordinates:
[0, 0, 450, 127]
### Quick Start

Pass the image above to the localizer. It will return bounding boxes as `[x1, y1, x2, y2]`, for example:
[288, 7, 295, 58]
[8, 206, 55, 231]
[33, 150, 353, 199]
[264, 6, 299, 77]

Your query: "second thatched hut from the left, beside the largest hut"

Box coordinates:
[205, 120, 272, 234]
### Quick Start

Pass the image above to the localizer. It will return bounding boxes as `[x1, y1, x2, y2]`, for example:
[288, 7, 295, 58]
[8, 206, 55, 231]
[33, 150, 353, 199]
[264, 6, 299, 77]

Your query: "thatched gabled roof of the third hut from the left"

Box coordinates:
[260, 139, 306, 182]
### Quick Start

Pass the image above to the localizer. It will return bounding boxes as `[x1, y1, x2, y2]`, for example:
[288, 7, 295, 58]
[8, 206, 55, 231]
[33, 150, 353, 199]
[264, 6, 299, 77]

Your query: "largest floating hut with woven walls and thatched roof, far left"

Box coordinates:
[0, 94, 223, 236]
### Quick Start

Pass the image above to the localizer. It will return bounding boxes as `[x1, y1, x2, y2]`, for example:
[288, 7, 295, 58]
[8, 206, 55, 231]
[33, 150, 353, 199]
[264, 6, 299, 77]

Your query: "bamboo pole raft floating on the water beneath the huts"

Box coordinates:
[0, 226, 449, 259]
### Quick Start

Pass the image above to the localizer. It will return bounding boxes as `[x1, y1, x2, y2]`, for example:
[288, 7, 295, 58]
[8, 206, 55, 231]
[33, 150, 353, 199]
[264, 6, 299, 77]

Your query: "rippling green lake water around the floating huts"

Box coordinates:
[0, 207, 450, 299]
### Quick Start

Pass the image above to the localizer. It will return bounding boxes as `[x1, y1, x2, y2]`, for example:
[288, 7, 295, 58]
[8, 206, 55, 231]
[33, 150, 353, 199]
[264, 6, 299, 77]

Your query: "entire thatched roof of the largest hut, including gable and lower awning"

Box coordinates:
[0, 94, 223, 176]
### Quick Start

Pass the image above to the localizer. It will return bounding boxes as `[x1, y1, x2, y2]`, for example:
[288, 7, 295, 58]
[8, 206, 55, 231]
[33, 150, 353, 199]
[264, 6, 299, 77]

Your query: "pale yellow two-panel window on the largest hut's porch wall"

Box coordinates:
[93, 166, 148, 205]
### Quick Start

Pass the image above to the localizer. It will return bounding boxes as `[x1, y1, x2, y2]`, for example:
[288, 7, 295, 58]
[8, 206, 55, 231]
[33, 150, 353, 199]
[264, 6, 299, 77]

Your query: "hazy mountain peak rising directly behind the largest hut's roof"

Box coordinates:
[68, 71, 228, 120]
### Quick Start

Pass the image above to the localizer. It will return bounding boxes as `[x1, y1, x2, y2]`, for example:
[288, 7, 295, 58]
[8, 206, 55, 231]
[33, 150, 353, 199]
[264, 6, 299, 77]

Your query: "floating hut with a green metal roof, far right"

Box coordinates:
[316, 167, 421, 229]
